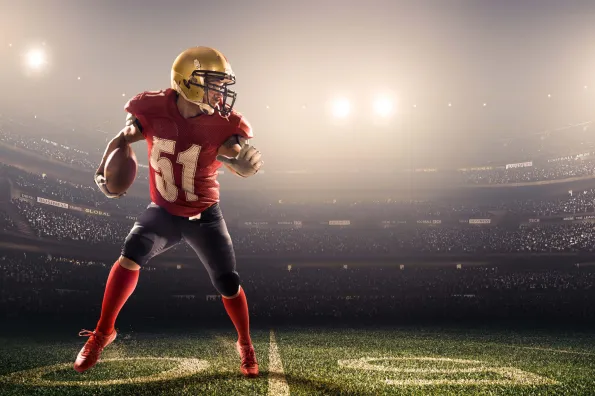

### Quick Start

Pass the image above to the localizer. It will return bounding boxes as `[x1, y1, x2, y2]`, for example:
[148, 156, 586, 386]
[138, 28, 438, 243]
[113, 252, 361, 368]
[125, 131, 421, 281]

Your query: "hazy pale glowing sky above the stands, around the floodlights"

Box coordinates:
[0, 0, 595, 165]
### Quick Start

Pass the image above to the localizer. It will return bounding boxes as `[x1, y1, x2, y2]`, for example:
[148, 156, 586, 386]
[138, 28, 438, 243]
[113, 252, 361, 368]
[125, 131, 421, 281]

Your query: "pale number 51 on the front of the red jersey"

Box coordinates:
[150, 137, 200, 202]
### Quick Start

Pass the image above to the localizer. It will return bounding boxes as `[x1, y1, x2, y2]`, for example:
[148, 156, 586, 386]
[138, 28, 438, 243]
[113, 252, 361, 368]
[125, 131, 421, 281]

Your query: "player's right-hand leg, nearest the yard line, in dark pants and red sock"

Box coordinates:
[182, 205, 258, 376]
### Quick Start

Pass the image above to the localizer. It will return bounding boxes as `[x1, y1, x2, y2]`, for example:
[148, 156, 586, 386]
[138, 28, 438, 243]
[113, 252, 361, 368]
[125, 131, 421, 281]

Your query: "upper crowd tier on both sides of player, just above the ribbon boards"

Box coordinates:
[0, 159, 595, 221]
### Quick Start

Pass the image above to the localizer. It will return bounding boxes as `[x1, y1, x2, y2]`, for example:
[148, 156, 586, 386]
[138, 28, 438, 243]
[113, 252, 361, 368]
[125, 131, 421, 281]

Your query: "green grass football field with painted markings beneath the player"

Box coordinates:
[0, 328, 595, 396]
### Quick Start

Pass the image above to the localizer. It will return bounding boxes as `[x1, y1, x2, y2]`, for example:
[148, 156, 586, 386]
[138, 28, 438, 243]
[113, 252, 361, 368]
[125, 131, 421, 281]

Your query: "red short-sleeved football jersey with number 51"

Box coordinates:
[125, 89, 252, 217]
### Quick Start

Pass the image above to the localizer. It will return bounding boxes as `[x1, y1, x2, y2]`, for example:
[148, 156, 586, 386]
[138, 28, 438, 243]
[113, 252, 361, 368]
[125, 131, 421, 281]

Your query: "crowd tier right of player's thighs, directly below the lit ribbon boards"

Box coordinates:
[232, 223, 595, 257]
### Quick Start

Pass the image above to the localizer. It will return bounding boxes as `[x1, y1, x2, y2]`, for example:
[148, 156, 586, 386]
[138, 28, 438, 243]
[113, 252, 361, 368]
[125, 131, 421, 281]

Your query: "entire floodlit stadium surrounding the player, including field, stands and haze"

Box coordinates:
[0, 0, 595, 395]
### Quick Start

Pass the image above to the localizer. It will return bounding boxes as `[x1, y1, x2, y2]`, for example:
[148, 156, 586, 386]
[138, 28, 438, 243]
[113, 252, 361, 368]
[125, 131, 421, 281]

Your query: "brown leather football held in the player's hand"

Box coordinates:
[104, 143, 138, 194]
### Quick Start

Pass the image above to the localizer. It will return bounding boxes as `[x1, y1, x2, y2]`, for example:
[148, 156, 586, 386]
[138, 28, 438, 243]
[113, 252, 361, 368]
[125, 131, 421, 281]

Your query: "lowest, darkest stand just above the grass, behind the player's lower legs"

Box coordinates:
[0, 253, 595, 325]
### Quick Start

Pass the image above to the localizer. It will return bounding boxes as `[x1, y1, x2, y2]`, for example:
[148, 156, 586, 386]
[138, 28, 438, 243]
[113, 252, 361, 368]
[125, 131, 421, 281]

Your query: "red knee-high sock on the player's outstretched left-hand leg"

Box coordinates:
[97, 261, 139, 334]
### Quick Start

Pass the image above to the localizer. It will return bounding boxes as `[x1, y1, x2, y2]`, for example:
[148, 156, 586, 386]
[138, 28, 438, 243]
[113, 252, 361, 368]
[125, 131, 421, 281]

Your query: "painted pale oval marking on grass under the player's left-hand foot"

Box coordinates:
[0, 357, 209, 386]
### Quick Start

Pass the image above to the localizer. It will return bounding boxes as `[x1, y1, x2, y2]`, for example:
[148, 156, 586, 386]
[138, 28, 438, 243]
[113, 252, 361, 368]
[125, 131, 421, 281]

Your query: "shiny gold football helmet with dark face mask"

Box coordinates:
[171, 47, 236, 117]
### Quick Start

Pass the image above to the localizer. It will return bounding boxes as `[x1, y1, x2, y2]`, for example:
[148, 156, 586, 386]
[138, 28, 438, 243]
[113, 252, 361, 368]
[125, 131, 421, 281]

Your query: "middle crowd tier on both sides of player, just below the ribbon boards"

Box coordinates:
[13, 196, 595, 257]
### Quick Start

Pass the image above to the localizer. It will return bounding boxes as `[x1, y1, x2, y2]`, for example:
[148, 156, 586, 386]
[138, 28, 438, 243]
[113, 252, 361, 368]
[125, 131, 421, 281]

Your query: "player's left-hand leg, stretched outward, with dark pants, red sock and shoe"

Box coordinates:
[74, 204, 182, 372]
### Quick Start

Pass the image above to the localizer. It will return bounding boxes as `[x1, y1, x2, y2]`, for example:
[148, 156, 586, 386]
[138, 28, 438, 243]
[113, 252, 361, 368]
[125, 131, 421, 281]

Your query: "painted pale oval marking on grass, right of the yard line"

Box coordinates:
[337, 356, 559, 386]
